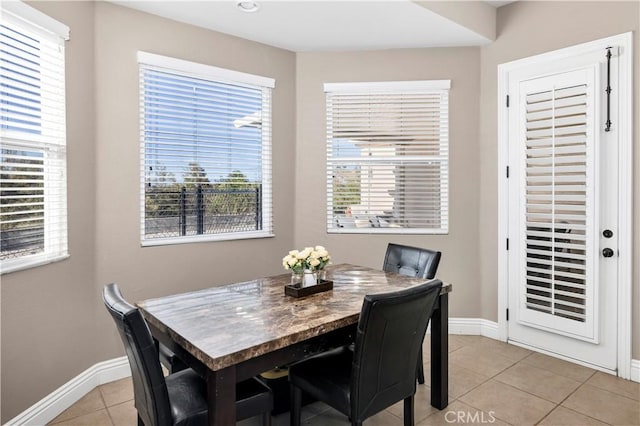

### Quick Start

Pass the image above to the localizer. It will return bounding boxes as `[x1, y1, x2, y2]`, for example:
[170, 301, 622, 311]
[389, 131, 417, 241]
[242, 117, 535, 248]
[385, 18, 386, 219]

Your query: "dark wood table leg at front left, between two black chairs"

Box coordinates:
[207, 366, 236, 426]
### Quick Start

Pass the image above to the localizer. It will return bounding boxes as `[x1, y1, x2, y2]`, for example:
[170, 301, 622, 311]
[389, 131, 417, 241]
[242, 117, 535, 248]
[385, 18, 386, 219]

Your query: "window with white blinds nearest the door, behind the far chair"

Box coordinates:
[325, 80, 450, 234]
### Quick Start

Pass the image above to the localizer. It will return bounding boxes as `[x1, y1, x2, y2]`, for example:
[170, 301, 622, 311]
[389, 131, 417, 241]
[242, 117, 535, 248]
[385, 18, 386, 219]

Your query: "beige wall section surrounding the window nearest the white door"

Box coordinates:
[295, 47, 481, 317]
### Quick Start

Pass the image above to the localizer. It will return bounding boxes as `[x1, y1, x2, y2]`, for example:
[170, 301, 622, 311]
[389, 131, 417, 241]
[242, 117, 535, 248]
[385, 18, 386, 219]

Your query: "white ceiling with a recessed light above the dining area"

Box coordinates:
[111, 0, 510, 52]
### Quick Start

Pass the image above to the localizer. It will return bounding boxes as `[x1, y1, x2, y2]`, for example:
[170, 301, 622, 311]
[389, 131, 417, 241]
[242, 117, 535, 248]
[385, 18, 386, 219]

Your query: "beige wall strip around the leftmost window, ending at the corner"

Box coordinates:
[0, 3, 97, 423]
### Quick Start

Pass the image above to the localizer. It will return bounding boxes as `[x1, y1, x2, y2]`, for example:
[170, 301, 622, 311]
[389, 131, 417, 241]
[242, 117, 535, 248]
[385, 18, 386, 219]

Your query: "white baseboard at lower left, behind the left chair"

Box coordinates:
[5, 356, 131, 426]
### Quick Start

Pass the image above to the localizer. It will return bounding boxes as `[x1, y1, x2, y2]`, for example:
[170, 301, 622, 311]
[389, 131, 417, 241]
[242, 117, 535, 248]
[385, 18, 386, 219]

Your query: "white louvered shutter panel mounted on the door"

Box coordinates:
[521, 70, 597, 340]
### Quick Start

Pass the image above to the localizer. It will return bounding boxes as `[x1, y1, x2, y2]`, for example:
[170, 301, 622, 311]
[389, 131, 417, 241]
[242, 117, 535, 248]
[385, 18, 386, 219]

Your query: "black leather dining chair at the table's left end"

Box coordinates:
[102, 284, 273, 426]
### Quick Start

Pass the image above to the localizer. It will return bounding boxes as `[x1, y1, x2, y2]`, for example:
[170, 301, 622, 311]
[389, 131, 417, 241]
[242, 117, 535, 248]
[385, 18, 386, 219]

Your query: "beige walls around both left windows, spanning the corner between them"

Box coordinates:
[1, 2, 295, 423]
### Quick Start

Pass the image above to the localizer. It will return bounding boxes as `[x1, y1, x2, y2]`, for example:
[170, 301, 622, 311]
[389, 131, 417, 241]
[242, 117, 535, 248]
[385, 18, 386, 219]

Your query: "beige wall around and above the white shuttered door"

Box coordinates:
[477, 1, 640, 359]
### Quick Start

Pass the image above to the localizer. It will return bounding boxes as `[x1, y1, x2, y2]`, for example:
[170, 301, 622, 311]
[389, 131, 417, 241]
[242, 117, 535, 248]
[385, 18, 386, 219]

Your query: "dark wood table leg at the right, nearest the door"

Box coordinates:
[431, 293, 449, 410]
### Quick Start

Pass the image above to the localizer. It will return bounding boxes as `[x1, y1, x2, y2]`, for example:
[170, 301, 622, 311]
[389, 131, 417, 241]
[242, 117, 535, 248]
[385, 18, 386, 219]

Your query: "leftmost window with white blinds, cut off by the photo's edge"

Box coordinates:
[0, 2, 69, 273]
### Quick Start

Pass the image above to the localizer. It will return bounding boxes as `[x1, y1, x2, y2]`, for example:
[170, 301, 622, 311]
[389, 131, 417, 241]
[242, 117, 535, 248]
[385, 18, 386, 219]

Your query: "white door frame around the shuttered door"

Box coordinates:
[498, 32, 634, 379]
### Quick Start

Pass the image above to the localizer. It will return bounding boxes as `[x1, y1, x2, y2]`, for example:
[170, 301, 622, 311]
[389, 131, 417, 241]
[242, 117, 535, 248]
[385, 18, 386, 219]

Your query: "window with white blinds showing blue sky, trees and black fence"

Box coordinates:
[138, 52, 274, 245]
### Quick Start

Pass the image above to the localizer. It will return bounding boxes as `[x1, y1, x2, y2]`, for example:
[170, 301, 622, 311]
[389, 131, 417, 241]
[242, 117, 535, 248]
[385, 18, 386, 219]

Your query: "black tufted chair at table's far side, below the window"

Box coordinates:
[382, 243, 442, 385]
